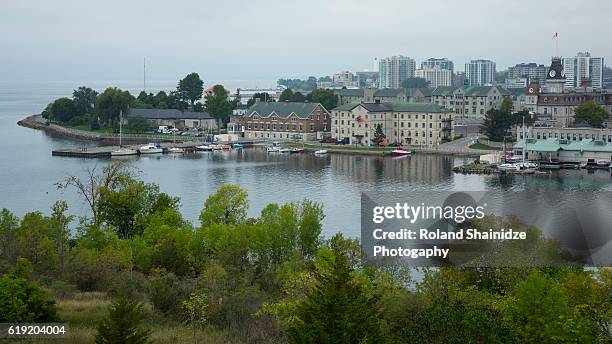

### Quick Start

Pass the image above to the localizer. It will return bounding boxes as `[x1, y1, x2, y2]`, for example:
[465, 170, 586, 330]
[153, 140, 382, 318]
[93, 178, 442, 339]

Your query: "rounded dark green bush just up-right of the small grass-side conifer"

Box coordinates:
[147, 269, 185, 314]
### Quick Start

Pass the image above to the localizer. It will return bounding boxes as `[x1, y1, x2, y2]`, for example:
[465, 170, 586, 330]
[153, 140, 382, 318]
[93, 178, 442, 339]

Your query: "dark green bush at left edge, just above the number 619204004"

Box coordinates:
[0, 273, 57, 323]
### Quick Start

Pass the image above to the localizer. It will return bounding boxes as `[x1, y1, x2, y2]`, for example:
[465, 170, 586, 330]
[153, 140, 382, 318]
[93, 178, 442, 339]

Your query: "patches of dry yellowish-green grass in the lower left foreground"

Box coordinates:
[8, 292, 242, 344]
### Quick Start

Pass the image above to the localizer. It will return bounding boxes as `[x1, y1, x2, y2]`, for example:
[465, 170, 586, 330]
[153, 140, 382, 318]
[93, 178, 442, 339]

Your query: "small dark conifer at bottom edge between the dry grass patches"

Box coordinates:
[96, 296, 151, 344]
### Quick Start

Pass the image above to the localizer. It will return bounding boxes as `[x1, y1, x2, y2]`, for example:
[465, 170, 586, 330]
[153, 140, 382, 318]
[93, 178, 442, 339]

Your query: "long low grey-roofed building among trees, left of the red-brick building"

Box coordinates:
[128, 108, 217, 130]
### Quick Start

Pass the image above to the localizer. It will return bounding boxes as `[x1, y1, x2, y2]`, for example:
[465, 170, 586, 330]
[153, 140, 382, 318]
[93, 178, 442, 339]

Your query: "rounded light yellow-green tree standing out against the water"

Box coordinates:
[200, 185, 249, 227]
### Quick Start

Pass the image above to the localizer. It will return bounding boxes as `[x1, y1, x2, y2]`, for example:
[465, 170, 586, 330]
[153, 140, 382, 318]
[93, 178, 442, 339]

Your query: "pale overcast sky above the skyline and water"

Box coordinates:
[0, 0, 612, 81]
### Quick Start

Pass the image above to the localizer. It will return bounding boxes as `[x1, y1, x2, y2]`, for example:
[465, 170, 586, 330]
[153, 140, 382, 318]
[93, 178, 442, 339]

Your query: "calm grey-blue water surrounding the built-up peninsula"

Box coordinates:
[0, 81, 612, 237]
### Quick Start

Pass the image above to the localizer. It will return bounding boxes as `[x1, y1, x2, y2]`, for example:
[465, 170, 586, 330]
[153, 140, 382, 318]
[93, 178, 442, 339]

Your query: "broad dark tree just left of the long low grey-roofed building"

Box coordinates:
[96, 87, 134, 128]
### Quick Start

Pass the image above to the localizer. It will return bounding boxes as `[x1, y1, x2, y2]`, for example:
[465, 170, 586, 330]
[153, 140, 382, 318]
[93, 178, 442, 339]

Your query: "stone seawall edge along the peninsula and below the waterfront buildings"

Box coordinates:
[17, 115, 491, 157]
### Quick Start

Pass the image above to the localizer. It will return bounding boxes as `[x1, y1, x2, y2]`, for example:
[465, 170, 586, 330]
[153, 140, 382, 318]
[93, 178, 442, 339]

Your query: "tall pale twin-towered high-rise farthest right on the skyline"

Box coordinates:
[563, 52, 604, 88]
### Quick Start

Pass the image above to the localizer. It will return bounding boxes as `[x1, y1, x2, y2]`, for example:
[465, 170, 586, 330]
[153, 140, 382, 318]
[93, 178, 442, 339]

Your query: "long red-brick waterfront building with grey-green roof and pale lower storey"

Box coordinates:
[231, 102, 331, 141]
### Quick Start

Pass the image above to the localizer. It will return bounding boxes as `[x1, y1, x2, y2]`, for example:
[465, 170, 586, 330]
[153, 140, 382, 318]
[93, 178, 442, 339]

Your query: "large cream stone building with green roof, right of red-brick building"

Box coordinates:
[332, 102, 453, 147]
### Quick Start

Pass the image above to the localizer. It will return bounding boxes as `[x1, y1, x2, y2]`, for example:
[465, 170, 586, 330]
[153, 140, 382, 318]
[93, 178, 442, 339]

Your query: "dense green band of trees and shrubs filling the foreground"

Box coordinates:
[0, 163, 612, 343]
